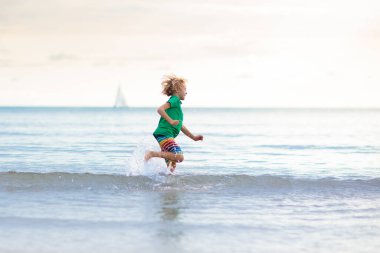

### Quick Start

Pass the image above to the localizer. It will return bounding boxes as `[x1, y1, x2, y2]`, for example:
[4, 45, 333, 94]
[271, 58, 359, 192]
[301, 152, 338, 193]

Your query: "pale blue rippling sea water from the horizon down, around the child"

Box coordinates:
[0, 107, 380, 253]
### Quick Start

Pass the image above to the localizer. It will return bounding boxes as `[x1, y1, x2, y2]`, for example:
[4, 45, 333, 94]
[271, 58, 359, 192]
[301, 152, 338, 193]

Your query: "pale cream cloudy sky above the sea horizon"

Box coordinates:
[0, 0, 380, 108]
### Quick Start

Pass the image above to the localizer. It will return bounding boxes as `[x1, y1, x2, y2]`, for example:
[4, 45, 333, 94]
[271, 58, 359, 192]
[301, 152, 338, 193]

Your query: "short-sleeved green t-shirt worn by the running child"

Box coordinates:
[153, 96, 183, 138]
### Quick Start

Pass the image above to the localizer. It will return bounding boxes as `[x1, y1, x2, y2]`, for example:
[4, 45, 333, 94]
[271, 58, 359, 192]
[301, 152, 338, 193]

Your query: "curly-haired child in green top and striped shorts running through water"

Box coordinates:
[145, 75, 203, 173]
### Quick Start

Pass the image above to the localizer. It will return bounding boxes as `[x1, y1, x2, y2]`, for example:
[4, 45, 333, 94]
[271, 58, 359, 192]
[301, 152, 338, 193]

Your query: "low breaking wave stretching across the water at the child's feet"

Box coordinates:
[0, 172, 380, 194]
